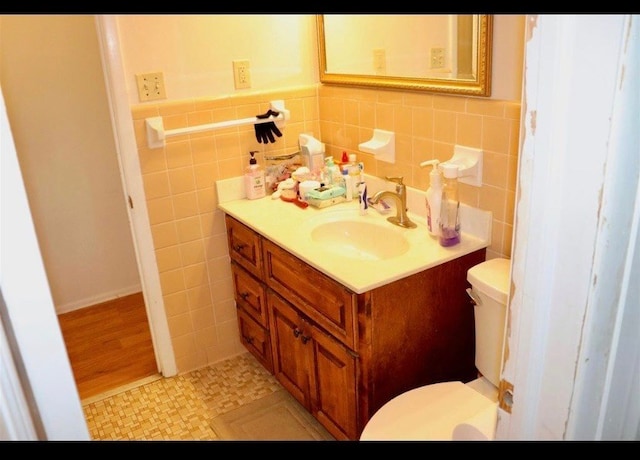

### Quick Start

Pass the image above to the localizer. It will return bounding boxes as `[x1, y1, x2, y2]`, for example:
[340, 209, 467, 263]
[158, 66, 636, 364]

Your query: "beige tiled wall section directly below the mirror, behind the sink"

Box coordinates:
[318, 85, 520, 258]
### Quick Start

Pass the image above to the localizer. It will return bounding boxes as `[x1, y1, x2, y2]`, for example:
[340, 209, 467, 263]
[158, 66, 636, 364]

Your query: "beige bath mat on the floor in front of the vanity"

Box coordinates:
[211, 390, 335, 441]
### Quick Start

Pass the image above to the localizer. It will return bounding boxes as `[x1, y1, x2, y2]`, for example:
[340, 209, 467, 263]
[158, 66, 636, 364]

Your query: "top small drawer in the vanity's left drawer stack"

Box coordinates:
[225, 215, 264, 279]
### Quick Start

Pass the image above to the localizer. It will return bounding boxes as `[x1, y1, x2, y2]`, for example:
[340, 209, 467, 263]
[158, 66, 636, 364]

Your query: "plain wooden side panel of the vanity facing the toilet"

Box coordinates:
[357, 249, 486, 426]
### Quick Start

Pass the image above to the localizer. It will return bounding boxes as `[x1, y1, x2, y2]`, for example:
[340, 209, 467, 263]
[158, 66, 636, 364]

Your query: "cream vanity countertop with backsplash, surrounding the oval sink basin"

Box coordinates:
[216, 175, 491, 294]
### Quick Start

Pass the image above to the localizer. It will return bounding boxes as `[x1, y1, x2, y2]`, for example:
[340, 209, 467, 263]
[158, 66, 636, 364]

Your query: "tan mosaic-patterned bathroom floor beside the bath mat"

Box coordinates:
[82, 353, 282, 441]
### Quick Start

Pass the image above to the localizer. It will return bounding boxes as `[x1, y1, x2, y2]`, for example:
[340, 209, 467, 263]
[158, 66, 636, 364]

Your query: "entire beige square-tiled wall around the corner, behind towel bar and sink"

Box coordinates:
[132, 85, 520, 373]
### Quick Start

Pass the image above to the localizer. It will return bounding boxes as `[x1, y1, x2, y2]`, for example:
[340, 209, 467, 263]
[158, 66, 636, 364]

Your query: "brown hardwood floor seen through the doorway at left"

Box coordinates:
[58, 293, 158, 399]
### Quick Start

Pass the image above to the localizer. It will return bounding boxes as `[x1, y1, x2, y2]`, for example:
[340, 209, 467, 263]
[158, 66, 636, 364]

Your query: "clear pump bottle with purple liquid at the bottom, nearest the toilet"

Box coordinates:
[438, 163, 460, 247]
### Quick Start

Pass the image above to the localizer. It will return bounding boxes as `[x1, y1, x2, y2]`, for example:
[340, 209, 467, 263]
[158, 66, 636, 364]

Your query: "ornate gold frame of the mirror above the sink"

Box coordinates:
[316, 14, 493, 97]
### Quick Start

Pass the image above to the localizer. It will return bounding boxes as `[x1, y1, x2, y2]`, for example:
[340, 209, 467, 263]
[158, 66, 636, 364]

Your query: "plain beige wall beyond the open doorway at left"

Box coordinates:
[0, 15, 141, 313]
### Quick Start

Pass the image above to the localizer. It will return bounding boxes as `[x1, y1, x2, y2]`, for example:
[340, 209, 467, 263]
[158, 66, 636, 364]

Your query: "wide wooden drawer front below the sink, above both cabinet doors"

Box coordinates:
[262, 239, 357, 350]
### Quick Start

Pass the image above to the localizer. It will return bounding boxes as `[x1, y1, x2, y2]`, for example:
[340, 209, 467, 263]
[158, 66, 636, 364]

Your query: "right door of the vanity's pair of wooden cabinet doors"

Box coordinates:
[309, 327, 359, 440]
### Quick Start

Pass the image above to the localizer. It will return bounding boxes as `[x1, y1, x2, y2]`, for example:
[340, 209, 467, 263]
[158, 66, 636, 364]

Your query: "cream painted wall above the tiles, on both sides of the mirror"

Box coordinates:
[117, 14, 524, 104]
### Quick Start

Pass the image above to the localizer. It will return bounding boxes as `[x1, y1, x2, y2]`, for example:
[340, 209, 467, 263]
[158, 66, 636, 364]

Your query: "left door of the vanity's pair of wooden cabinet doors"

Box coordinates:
[267, 291, 311, 409]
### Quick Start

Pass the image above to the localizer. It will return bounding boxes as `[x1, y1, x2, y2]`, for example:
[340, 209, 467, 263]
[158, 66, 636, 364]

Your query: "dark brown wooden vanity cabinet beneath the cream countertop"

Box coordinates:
[226, 216, 486, 440]
